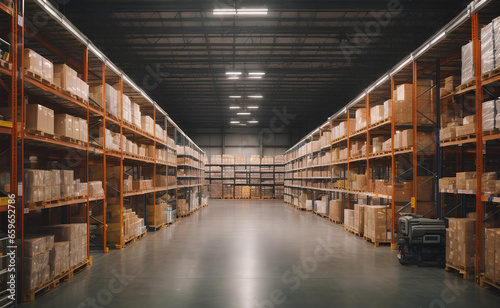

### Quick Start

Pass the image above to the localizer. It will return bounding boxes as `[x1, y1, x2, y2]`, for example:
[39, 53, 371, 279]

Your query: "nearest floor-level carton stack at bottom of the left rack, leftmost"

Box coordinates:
[23, 235, 54, 291]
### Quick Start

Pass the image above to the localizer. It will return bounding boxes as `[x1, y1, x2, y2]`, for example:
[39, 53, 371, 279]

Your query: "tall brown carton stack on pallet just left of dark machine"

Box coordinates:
[364, 205, 392, 242]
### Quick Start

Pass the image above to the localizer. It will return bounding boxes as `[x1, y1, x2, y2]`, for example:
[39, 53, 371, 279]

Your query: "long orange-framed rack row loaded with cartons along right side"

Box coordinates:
[285, 1, 500, 288]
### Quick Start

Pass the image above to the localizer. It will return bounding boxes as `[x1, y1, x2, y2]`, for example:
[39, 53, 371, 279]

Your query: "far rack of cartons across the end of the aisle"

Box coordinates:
[206, 155, 285, 199]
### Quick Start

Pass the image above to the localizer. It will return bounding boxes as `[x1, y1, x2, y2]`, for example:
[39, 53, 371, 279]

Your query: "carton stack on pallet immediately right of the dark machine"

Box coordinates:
[446, 218, 476, 268]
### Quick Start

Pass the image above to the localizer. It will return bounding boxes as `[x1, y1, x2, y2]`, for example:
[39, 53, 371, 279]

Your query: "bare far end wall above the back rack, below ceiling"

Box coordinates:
[189, 128, 292, 157]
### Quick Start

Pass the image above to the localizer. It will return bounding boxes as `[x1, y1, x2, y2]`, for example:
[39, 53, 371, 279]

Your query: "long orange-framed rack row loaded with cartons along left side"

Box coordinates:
[0, 0, 204, 305]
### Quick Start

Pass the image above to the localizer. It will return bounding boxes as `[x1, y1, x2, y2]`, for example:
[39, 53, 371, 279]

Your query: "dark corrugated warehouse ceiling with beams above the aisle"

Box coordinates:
[54, 0, 470, 134]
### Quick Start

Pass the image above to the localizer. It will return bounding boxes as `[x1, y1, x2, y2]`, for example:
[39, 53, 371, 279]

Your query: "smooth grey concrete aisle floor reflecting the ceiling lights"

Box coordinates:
[21, 200, 500, 308]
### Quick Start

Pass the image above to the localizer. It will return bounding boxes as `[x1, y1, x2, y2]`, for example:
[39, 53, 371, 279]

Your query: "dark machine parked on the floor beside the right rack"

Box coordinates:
[398, 214, 446, 267]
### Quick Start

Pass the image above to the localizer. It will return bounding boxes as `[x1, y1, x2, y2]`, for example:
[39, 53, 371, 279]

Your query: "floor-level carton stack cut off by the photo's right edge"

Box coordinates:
[484, 228, 500, 283]
